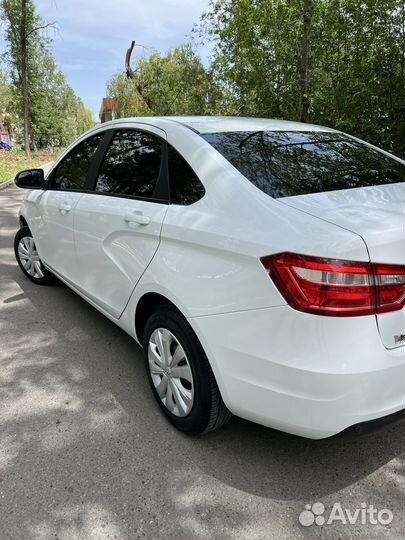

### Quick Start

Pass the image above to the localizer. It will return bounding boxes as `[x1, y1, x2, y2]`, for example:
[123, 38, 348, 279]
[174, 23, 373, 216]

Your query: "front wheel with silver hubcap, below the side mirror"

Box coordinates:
[14, 227, 54, 285]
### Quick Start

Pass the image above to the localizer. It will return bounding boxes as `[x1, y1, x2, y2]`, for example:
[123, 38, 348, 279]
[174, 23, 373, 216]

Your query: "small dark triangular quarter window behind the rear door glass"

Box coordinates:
[167, 144, 205, 205]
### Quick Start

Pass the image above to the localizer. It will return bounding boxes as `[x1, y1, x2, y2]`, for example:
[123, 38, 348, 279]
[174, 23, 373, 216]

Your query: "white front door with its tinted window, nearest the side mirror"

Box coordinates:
[35, 133, 105, 283]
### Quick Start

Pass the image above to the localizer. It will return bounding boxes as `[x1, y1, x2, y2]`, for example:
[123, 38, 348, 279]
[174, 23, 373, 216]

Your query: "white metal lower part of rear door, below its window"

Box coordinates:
[75, 193, 167, 319]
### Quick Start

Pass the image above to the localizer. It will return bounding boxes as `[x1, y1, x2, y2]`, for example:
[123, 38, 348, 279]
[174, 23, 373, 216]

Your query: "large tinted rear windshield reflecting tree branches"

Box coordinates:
[202, 131, 405, 198]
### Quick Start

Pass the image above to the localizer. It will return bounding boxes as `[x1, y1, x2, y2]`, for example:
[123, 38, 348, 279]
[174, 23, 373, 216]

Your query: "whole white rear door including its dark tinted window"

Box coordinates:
[75, 126, 168, 318]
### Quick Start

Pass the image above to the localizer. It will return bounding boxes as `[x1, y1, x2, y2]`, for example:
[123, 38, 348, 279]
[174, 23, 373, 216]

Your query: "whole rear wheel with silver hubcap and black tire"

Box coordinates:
[143, 307, 231, 435]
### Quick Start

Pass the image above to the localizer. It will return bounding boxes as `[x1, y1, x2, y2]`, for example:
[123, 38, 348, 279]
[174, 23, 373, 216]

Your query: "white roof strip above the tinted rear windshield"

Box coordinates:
[160, 116, 335, 133]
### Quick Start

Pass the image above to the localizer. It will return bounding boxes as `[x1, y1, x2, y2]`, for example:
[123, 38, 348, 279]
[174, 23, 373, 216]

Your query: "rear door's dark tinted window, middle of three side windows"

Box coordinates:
[96, 130, 162, 198]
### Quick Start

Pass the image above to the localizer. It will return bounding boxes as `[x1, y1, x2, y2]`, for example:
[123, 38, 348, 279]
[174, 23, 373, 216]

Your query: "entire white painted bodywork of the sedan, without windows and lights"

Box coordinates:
[21, 117, 405, 438]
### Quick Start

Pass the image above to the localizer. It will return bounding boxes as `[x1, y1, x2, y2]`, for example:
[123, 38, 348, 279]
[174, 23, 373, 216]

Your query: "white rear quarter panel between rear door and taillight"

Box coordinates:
[132, 134, 368, 317]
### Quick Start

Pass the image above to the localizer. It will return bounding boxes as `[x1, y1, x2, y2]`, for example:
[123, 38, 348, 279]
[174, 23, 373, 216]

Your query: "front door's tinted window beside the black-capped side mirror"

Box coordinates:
[50, 133, 104, 191]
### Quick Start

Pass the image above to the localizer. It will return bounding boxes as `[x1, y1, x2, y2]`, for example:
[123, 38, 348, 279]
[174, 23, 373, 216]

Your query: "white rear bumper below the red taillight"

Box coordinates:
[189, 306, 405, 439]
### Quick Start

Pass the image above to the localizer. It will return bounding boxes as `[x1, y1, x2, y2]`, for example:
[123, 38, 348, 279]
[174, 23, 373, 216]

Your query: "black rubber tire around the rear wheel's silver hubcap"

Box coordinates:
[143, 306, 231, 435]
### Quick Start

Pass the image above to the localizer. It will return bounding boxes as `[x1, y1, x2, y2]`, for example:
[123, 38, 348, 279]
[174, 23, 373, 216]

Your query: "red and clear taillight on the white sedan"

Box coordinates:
[260, 253, 405, 317]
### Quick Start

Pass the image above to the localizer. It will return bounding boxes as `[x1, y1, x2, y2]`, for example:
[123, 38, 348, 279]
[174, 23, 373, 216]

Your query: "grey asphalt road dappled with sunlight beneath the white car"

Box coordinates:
[0, 184, 405, 540]
